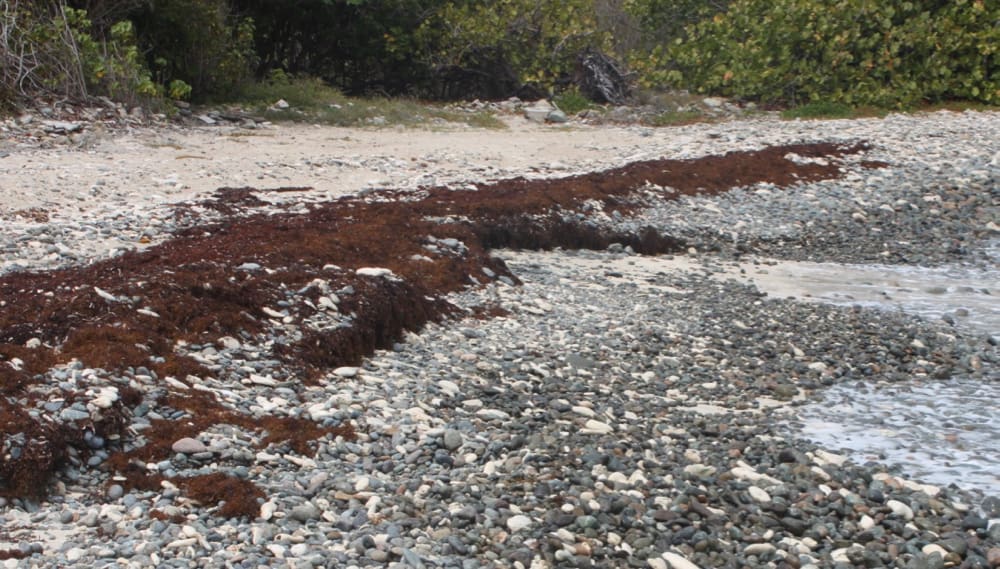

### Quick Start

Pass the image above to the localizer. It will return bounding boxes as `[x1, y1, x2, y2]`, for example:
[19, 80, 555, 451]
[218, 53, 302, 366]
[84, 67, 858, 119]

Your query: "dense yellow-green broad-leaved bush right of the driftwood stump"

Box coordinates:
[645, 0, 1000, 107]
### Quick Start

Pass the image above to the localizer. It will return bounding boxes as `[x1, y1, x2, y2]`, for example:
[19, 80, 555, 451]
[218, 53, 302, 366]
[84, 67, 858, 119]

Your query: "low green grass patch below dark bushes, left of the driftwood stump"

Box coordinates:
[239, 75, 506, 128]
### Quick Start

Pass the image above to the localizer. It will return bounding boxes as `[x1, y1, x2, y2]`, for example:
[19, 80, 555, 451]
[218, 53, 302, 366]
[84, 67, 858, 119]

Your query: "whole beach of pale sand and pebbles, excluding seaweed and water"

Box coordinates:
[0, 111, 1000, 569]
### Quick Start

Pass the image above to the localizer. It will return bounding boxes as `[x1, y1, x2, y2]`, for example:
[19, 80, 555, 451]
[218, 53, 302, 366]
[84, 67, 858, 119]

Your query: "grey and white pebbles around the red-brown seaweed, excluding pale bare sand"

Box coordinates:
[0, 113, 1000, 569]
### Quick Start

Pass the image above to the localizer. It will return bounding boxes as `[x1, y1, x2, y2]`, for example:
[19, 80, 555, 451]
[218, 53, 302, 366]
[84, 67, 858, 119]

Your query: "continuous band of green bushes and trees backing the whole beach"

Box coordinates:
[0, 0, 1000, 107]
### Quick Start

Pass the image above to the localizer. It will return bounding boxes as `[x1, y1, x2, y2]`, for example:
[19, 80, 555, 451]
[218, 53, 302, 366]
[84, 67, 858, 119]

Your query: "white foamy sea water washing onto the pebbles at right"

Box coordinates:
[747, 242, 1000, 508]
